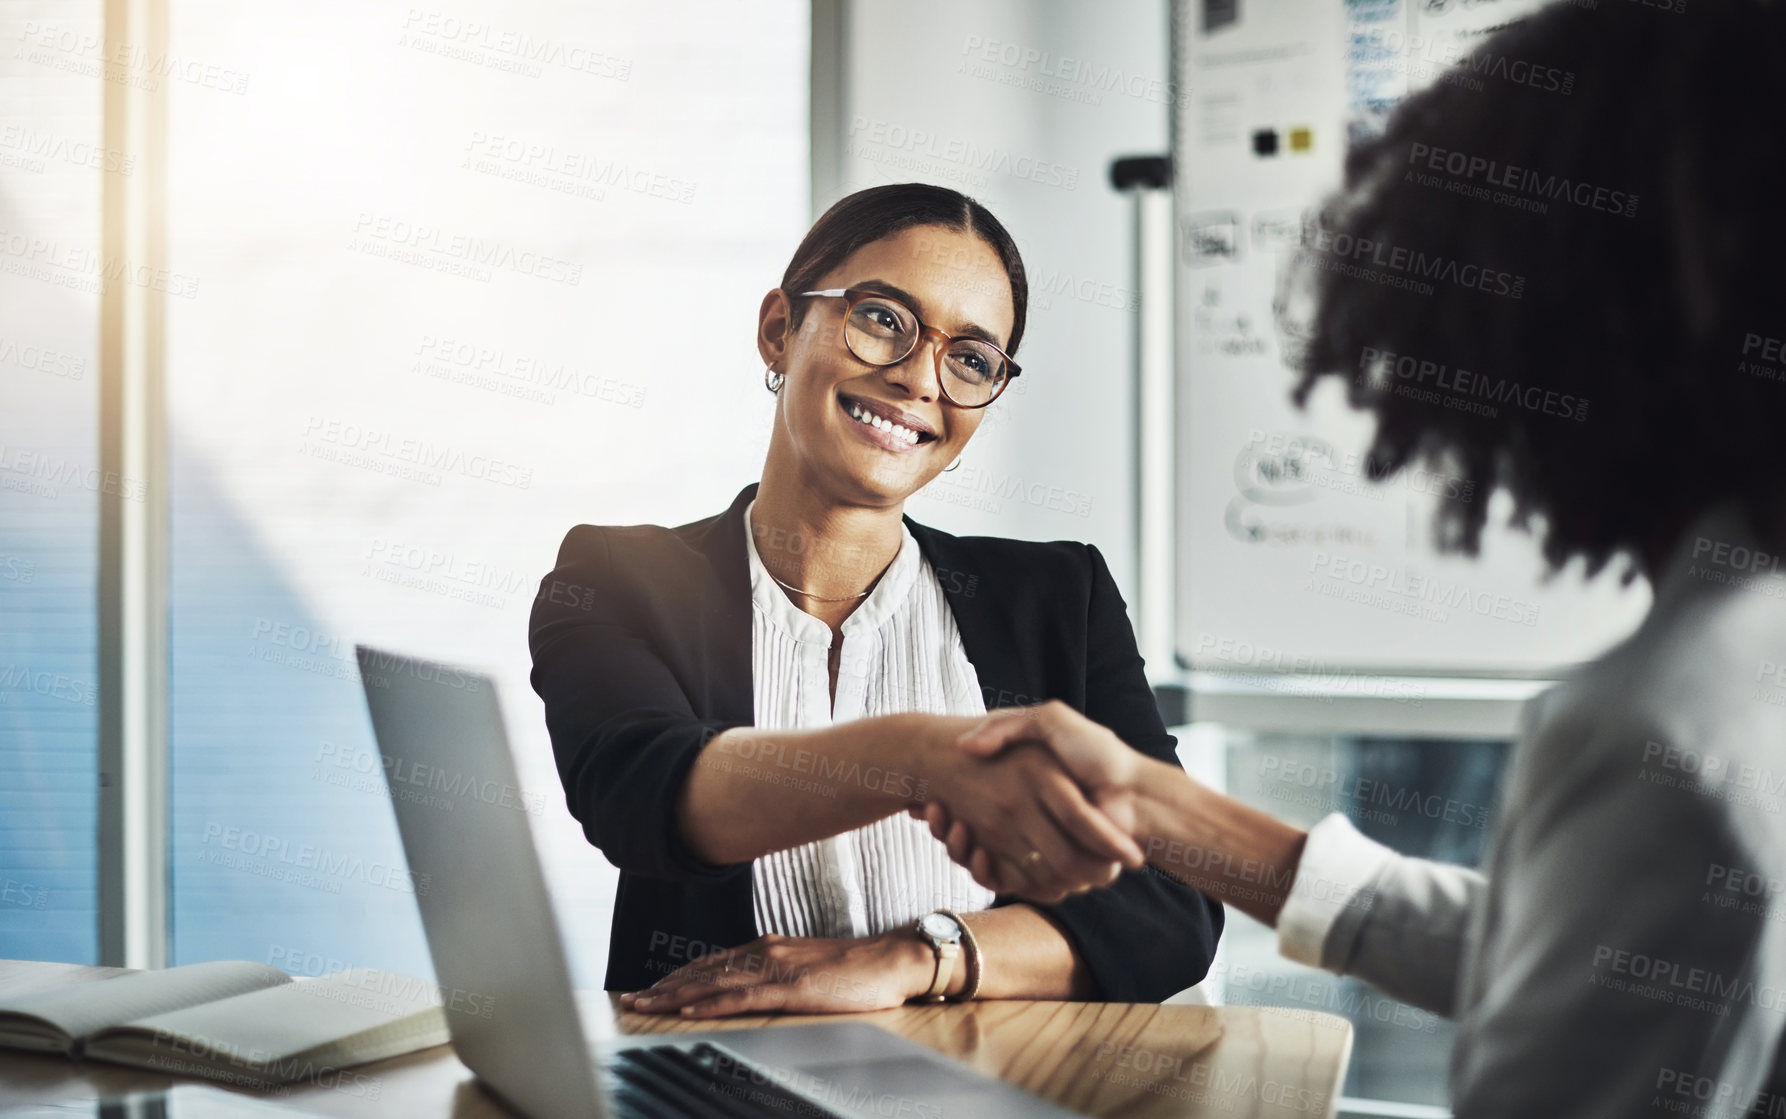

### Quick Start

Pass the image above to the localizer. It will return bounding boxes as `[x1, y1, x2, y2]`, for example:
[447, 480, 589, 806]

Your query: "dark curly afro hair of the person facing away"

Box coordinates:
[1286, 0, 1786, 580]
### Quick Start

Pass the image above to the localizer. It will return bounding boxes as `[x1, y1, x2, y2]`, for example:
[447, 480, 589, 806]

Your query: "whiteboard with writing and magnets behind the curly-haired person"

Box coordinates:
[1173, 0, 1648, 676]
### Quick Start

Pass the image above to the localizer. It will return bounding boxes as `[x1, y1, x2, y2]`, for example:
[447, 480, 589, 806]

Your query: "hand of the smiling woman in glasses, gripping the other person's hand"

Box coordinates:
[911, 719, 1145, 903]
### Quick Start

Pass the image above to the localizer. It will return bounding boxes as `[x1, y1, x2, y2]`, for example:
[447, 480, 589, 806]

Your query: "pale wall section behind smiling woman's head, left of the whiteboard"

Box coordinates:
[814, 0, 1168, 600]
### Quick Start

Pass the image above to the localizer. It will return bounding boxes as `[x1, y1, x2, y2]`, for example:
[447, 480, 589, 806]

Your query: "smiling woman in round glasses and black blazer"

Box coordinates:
[529, 184, 1222, 1017]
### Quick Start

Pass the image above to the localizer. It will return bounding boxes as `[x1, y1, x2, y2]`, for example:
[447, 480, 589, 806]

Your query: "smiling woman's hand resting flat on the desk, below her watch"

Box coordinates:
[620, 930, 936, 1017]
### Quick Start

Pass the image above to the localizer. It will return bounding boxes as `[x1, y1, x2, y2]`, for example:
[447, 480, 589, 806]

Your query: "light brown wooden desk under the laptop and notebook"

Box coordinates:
[0, 960, 1352, 1119]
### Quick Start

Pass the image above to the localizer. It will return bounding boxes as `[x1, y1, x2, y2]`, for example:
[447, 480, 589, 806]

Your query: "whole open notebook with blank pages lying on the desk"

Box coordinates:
[0, 960, 453, 1083]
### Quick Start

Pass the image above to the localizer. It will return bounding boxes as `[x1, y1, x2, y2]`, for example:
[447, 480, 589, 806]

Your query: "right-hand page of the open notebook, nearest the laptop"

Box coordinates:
[88, 967, 447, 1071]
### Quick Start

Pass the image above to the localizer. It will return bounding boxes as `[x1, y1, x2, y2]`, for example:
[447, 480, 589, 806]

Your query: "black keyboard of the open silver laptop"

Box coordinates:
[607, 1042, 845, 1119]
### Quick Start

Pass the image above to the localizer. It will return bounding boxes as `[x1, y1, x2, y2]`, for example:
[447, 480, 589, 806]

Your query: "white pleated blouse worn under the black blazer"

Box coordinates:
[745, 501, 993, 937]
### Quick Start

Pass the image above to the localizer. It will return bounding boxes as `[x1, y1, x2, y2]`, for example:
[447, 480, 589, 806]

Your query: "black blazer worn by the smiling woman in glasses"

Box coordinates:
[529, 485, 1222, 1001]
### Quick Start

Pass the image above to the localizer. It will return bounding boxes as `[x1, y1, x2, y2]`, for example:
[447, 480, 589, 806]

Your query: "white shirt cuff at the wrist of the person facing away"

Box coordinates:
[1277, 812, 1395, 971]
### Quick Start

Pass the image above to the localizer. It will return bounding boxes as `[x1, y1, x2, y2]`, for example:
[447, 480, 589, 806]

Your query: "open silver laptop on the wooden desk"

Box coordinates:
[355, 646, 1072, 1119]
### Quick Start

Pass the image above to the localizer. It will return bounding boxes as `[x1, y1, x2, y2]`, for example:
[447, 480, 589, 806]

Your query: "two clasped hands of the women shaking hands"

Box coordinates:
[907, 700, 1191, 903]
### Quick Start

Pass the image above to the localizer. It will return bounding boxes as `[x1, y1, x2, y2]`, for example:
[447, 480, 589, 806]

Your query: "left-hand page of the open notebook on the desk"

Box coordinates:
[0, 960, 291, 1039]
